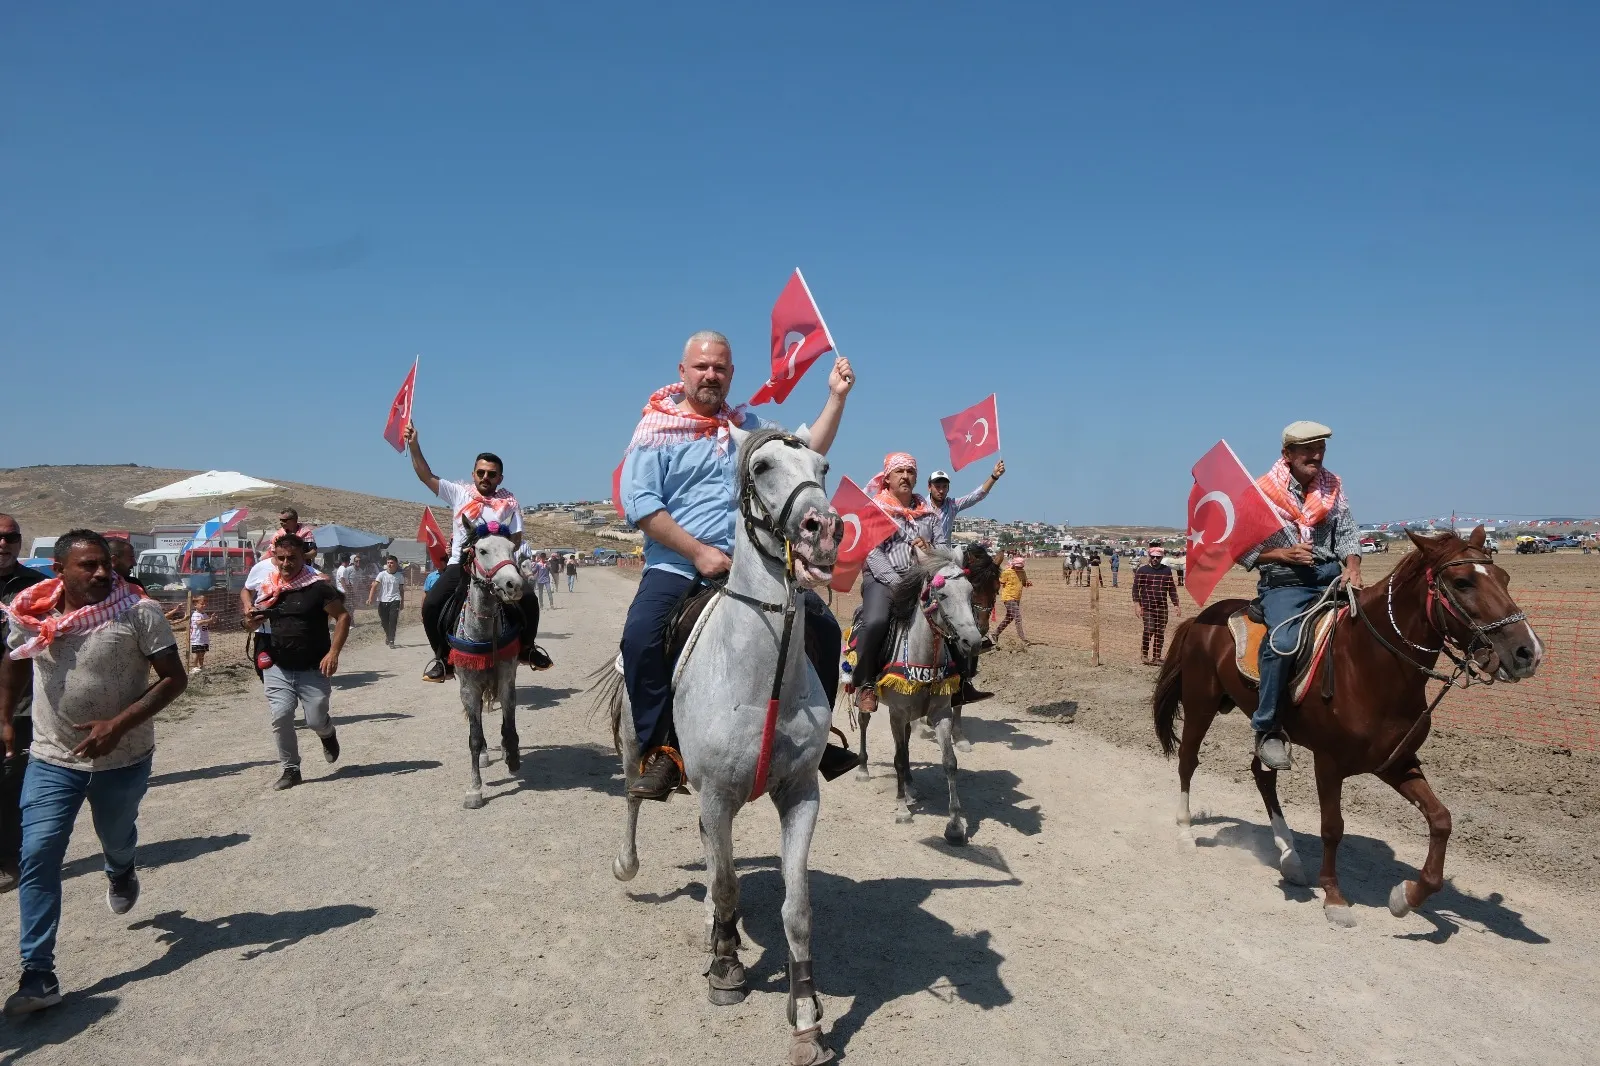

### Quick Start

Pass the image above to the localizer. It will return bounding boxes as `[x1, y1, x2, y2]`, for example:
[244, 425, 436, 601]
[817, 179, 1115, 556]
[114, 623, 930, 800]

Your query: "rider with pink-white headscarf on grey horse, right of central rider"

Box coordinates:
[854, 451, 938, 714]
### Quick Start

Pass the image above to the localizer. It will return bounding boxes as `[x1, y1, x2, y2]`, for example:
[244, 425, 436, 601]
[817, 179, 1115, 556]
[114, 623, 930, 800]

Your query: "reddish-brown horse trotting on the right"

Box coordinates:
[1152, 527, 1544, 925]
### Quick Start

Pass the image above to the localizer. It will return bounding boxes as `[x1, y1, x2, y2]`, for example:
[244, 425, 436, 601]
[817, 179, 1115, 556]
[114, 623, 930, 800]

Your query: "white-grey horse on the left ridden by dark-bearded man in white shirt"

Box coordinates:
[450, 520, 533, 810]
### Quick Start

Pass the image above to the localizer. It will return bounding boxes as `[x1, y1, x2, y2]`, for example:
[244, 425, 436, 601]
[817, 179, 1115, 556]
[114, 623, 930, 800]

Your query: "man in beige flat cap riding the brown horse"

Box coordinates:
[1238, 421, 1362, 770]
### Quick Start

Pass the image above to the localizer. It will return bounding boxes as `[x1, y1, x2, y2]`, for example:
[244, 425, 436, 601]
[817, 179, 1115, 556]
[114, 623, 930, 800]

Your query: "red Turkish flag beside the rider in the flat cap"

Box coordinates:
[1184, 440, 1283, 607]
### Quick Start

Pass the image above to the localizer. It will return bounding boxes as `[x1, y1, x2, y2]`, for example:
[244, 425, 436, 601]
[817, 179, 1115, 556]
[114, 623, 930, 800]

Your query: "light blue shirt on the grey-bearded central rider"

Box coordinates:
[622, 411, 779, 578]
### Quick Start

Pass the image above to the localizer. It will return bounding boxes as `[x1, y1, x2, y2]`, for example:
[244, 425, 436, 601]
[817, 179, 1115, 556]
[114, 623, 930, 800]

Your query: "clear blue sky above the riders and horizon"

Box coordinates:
[0, 3, 1600, 525]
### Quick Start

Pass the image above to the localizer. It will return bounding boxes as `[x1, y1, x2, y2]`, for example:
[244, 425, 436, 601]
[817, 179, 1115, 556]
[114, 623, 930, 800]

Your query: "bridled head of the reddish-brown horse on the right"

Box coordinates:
[1406, 525, 1544, 680]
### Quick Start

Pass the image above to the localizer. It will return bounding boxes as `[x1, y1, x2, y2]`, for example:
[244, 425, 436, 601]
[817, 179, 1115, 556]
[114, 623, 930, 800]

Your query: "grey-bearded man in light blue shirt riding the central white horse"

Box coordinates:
[619, 330, 856, 800]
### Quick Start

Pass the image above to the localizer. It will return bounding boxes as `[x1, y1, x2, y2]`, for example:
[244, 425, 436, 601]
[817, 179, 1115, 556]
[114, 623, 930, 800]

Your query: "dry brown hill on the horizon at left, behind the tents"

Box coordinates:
[0, 464, 618, 551]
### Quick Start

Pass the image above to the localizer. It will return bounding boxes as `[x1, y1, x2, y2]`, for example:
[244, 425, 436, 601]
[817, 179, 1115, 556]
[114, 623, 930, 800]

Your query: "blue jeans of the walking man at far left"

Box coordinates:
[16, 759, 150, 970]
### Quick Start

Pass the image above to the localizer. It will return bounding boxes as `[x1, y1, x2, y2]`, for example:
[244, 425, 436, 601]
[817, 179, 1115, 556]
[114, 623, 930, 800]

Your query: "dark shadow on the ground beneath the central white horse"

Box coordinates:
[646, 856, 1022, 1055]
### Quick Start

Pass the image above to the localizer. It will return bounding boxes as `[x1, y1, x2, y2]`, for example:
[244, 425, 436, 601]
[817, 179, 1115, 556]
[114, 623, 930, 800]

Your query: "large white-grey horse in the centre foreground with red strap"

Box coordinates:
[602, 427, 840, 1066]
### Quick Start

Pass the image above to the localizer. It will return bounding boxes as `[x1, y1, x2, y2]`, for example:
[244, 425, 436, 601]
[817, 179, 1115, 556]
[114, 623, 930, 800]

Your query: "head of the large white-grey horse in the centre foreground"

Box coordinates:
[733, 426, 840, 587]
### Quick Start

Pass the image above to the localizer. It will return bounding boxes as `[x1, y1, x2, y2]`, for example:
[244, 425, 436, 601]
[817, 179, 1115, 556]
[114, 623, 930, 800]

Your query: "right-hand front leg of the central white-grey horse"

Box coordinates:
[773, 773, 834, 1066]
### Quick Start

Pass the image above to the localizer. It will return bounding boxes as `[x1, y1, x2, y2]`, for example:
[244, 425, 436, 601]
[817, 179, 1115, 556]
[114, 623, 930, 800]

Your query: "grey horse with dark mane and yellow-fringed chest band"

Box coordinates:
[862, 549, 984, 845]
